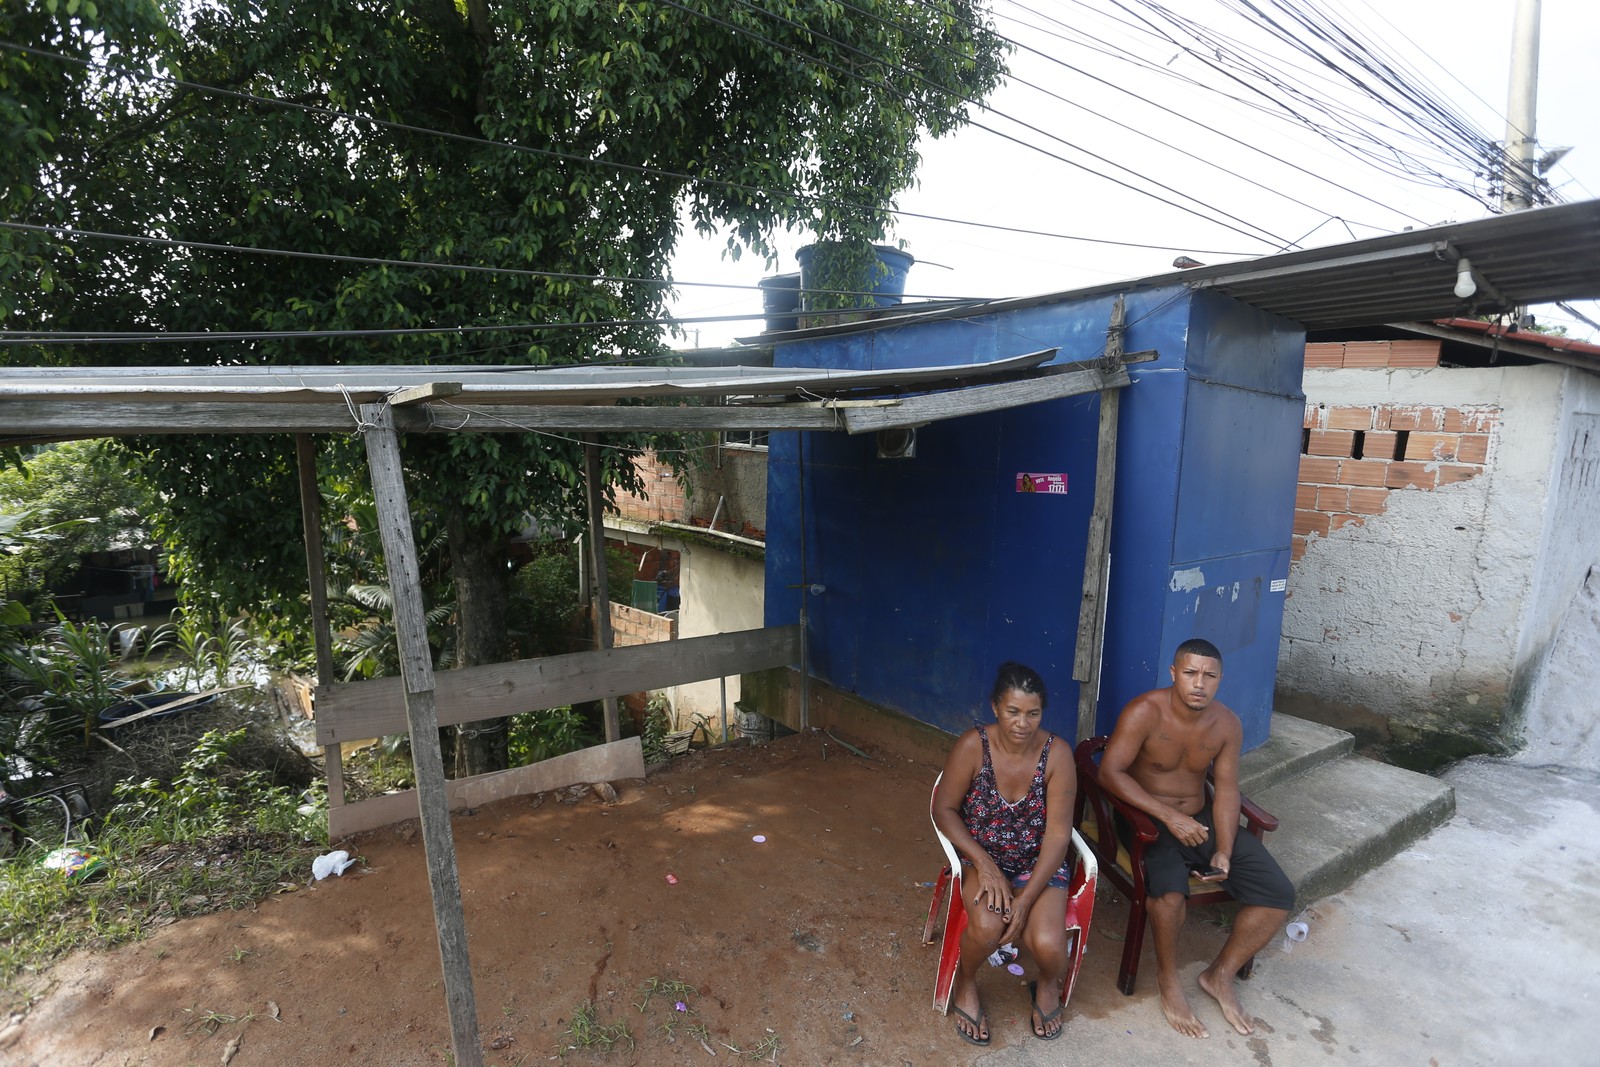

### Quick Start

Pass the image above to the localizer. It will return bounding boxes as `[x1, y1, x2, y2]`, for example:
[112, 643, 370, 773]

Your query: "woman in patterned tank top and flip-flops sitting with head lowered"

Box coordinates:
[933, 662, 1077, 1045]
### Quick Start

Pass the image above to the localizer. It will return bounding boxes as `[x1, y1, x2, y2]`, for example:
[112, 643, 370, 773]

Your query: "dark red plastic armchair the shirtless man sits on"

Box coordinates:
[1072, 736, 1278, 997]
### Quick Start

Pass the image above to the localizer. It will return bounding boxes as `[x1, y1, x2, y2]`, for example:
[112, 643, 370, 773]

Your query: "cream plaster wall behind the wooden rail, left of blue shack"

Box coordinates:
[669, 541, 766, 734]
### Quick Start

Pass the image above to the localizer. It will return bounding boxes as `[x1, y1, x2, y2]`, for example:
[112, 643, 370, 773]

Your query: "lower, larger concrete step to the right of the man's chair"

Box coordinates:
[1246, 751, 1456, 907]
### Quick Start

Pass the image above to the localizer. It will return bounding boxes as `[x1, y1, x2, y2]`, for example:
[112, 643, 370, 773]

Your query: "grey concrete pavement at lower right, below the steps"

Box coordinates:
[966, 760, 1600, 1067]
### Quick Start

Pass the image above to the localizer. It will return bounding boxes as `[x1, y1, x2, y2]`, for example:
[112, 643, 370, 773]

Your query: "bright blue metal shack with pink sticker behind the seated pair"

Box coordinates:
[766, 286, 1304, 749]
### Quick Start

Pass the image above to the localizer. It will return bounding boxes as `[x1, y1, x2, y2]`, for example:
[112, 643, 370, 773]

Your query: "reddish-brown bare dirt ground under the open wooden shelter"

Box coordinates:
[0, 733, 1222, 1067]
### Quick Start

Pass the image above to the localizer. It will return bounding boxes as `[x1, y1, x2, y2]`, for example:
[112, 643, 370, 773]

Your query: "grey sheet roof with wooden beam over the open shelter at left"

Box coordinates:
[0, 349, 1134, 445]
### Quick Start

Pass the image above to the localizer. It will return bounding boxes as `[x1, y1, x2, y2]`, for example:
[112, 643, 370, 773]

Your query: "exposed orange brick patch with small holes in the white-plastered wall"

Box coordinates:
[1293, 404, 1501, 560]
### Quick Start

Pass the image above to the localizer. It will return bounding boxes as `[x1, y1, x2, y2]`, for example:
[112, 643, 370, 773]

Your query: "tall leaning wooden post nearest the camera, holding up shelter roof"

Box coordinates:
[362, 403, 483, 1067]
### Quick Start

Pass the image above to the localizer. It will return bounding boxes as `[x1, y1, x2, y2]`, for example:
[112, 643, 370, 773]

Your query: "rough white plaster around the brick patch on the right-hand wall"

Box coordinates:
[1278, 366, 1566, 739]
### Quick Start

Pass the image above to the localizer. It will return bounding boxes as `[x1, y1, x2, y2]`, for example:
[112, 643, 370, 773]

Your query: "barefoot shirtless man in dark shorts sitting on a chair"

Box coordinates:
[1101, 638, 1294, 1037]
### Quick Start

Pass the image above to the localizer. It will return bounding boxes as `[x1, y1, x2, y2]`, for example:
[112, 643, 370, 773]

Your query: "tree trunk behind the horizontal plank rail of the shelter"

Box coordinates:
[445, 510, 510, 777]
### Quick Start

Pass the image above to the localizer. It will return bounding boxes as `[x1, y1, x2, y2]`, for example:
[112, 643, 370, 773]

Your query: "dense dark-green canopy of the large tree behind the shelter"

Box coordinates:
[0, 0, 1002, 767]
